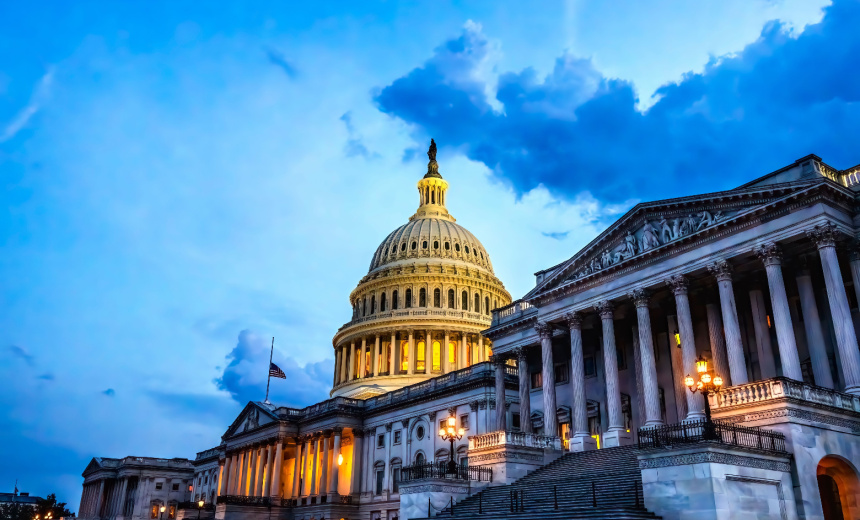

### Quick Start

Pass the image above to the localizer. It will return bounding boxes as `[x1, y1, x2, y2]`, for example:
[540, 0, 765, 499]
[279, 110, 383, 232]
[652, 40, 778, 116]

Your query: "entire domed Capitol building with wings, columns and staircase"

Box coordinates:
[79, 143, 860, 520]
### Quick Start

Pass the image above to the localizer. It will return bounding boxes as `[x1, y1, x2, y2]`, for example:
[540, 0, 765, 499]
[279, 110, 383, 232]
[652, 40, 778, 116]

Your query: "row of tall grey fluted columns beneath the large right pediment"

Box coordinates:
[496, 223, 860, 450]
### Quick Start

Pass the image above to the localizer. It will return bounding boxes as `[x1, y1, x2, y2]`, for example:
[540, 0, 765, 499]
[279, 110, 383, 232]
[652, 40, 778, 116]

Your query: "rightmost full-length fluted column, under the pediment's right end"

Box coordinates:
[807, 222, 860, 395]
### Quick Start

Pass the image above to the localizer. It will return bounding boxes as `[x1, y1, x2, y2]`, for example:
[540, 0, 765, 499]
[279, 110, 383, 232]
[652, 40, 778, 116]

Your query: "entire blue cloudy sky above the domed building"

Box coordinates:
[0, 0, 860, 510]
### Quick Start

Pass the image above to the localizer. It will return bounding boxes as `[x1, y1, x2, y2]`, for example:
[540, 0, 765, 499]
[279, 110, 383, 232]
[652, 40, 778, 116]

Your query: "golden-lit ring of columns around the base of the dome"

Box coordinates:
[334, 330, 487, 386]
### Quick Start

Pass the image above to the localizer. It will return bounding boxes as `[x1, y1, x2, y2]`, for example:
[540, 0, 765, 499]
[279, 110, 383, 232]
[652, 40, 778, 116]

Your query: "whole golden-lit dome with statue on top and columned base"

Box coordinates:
[332, 140, 511, 398]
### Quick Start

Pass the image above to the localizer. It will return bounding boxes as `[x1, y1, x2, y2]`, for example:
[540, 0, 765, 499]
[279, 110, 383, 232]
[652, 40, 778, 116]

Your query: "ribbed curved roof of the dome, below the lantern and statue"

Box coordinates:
[370, 217, 493, 273]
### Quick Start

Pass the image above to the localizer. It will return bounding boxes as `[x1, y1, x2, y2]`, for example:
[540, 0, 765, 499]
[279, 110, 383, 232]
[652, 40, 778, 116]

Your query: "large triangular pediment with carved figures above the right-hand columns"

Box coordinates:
[524, 180, 844, 301]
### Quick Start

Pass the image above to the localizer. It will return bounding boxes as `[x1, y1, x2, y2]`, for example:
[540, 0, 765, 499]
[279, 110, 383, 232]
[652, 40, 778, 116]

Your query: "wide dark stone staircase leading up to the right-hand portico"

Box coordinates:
[428, 446, 660, 520]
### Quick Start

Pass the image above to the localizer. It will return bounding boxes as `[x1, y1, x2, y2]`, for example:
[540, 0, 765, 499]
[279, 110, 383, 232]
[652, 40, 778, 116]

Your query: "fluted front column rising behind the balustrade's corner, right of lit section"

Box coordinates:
[756, 244, 803, 381]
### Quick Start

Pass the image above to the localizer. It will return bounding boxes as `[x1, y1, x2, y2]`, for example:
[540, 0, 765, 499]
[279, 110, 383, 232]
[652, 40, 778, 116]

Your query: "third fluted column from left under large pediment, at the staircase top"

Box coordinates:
[597, 301, 633, 448]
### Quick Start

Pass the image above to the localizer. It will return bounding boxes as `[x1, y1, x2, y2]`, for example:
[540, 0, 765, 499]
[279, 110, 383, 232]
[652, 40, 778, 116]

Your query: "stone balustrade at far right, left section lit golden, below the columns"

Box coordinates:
[708, 377, 860, 412]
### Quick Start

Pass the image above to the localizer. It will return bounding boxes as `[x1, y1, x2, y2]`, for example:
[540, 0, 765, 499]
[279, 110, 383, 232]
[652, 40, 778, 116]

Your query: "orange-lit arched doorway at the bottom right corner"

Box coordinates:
[816, 455, 860, 520]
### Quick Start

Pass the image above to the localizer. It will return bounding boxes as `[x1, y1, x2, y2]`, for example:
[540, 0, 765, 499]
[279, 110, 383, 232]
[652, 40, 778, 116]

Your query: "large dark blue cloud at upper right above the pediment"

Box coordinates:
[375, 0, 860, 202]
